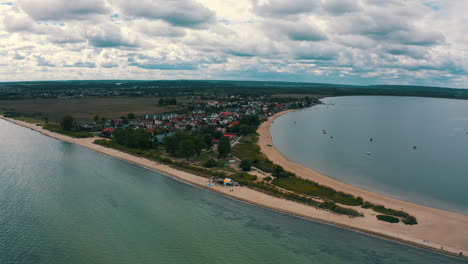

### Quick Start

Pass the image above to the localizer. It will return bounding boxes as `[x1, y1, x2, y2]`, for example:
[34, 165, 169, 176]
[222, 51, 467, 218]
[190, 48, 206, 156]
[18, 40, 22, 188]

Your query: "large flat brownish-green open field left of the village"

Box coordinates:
[0, 97, 176, 122]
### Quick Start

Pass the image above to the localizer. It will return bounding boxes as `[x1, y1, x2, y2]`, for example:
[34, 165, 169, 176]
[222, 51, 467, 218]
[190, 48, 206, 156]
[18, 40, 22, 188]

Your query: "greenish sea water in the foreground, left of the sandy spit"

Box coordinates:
[0, 120, 466, 264]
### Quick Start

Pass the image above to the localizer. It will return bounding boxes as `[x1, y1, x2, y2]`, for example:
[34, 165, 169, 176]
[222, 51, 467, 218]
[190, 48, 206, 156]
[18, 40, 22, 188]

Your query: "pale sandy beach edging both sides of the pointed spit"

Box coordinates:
[0, 114, 468, 257]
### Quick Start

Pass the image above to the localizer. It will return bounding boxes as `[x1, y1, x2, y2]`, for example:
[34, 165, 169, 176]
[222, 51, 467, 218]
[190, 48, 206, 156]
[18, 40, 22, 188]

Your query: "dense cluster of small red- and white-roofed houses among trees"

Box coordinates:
[98, 97, 310, 140]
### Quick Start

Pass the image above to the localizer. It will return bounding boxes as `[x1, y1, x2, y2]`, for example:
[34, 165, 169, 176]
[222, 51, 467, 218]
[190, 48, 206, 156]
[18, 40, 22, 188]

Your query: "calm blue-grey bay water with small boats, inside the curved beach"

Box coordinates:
[271, 96, 468, 214]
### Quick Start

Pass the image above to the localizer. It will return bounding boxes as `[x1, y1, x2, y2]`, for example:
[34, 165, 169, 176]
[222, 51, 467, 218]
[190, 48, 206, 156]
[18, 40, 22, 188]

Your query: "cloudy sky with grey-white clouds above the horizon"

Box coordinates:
[0, 0, 468, 88]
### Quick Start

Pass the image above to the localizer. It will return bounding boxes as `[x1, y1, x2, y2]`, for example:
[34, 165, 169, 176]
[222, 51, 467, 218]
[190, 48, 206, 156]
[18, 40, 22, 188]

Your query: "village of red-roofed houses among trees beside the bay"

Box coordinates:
[97, 96, 318, 144]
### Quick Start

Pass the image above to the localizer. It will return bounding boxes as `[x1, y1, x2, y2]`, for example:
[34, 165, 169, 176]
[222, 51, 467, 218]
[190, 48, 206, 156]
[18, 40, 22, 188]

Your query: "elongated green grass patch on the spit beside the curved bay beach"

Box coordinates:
[273, 177, 363, 206]
